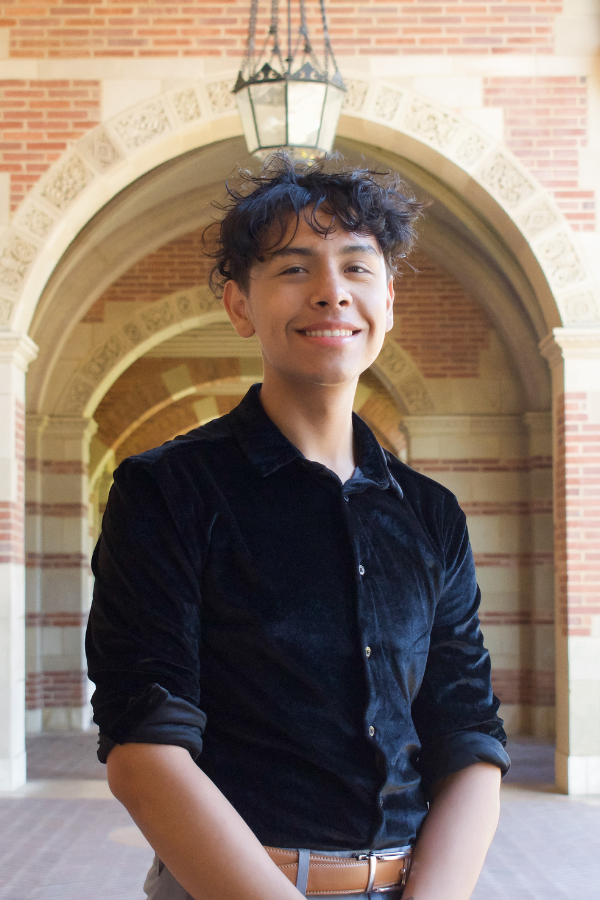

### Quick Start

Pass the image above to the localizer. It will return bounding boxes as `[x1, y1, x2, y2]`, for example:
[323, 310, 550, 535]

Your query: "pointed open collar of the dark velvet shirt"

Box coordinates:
[230, 384, 398, 492]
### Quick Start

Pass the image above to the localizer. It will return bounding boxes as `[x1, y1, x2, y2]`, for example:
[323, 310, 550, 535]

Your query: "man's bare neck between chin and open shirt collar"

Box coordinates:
[260, 371, 357, 482]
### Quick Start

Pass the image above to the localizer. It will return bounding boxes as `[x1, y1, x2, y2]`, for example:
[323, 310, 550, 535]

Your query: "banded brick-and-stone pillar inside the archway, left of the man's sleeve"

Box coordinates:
[26, 416, 96, 731]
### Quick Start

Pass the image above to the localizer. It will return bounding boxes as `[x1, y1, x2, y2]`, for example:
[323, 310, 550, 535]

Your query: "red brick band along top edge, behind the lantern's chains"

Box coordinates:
[0, 0, 562, 58]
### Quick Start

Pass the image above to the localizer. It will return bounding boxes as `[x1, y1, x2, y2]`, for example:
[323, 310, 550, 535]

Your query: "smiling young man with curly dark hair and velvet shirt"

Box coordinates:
[87, 154, 508, 900]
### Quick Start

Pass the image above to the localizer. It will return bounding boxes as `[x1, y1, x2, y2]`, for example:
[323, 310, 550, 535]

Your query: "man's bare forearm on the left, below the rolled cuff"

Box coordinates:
[107, 744, 302, 900]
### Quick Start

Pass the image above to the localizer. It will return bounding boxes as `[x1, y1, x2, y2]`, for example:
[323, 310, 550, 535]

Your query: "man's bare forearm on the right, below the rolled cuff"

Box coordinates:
[403, 763, 500, 900]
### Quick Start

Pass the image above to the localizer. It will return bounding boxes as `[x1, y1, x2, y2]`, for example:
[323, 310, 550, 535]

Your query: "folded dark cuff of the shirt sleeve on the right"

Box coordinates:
[417, 731, 510, 796]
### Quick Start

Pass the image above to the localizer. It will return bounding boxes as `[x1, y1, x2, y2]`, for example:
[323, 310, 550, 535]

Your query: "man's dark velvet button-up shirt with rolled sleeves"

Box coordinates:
[86, 385, 509, 850]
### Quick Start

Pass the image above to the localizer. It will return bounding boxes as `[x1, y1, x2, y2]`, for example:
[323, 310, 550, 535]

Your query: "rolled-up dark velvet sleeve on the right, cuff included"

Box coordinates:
[412, 506, 510, 796]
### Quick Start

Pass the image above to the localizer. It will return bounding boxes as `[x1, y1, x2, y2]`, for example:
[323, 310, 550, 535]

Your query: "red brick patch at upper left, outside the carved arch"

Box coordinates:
[0, 80, 100, 210]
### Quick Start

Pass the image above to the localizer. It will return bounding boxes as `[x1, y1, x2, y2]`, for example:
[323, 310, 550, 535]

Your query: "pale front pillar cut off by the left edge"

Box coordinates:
[0, 331, 37, 790]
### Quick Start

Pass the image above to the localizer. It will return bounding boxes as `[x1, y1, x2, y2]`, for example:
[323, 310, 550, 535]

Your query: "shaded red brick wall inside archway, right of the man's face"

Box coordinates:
[394, 253, 491, 378]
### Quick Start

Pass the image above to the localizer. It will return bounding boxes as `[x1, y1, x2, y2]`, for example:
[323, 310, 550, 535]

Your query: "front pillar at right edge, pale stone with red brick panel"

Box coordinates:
[540, 327, 600, 794]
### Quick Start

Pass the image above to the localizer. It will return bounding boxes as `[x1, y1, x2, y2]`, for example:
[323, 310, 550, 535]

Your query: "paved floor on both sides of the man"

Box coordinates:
[0, 734, 600, 900]
